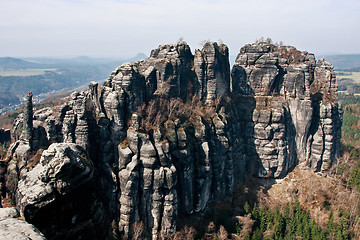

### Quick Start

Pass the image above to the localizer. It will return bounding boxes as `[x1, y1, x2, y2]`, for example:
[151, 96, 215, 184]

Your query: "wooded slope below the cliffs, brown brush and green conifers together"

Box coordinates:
[165, 167, 360, 240]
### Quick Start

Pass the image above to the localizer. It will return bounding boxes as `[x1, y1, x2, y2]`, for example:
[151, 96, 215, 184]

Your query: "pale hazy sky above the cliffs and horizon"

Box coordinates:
[0, 0, 360, 57]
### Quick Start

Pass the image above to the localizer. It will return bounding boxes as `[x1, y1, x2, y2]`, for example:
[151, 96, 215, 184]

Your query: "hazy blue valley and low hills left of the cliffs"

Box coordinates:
[0, 53, 147, 112]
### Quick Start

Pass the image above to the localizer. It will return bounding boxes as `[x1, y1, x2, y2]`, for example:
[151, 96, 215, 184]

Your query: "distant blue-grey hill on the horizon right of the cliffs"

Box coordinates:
[322, 54, 360, 71]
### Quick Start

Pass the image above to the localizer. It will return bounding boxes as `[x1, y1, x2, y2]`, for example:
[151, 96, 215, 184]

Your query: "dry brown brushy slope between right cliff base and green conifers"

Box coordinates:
[260, 166, 360, 232]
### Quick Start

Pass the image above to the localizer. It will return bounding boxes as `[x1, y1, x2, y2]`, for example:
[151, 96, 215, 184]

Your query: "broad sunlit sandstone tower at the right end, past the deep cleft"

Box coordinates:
[232, 43, 341, 177]
